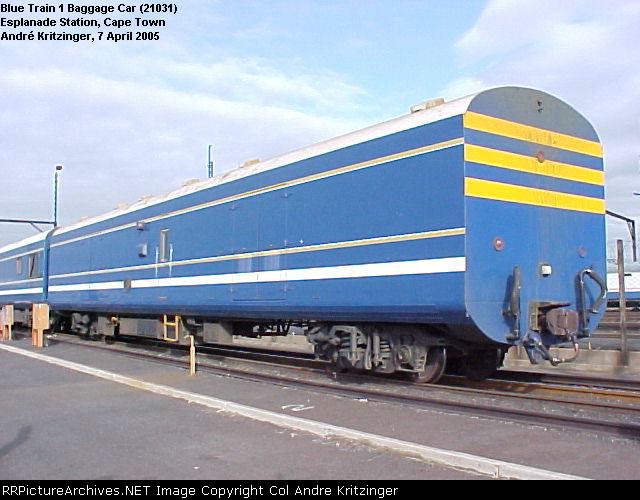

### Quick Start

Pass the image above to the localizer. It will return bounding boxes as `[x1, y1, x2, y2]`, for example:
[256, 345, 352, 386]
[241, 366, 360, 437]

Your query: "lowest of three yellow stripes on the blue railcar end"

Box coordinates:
[465, 177, 606, 215]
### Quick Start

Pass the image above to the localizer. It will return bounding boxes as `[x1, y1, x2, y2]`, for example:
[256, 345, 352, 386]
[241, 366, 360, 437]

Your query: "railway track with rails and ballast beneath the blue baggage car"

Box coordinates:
[32, 334, 640, 439]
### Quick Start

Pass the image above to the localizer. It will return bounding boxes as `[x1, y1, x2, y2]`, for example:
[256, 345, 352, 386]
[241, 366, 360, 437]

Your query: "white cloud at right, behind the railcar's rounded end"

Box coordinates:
[443, 0, 640, 256]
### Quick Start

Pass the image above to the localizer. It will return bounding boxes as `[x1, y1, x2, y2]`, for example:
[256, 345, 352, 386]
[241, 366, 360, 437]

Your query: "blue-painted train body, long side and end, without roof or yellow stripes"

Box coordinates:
[0, 89, 605, 343]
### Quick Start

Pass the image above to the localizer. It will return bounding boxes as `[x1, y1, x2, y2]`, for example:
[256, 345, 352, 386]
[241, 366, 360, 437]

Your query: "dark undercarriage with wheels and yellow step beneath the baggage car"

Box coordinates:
[46, 312, 504, 383]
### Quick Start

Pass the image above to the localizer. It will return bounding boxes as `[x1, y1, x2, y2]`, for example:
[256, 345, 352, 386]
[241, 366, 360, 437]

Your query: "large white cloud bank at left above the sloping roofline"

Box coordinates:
[0, 16, 365, 245]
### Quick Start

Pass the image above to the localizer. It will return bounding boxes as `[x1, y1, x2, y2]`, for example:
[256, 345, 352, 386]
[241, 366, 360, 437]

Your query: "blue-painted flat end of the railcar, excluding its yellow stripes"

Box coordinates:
[465, 88, 606, 344]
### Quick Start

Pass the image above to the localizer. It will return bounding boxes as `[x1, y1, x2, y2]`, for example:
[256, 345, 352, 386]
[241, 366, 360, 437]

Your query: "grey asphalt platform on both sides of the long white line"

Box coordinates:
[0, 343, 640, 479]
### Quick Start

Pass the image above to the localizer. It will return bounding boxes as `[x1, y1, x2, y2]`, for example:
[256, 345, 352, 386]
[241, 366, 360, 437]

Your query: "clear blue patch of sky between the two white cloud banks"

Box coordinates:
[180, 0, 485, 114]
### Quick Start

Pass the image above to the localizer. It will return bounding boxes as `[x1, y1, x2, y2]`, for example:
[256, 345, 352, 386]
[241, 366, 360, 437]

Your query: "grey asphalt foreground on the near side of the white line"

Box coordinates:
[0, 344, 477, 480]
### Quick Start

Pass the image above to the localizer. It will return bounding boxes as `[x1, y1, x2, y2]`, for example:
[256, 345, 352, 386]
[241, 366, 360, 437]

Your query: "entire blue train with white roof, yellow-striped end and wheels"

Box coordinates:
[0, 87, 606, 381]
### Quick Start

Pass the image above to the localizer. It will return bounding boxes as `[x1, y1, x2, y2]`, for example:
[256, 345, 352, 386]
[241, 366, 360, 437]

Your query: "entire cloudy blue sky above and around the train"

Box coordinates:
[0, 0, 640, 254]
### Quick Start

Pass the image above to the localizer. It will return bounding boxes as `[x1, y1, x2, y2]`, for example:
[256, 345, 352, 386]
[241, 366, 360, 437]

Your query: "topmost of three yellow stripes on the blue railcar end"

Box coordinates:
[464, 111, 603, 158]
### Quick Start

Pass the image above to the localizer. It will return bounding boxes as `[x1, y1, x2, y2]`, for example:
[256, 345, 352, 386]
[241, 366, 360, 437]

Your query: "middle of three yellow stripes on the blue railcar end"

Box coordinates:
[464, 144, 604, 186]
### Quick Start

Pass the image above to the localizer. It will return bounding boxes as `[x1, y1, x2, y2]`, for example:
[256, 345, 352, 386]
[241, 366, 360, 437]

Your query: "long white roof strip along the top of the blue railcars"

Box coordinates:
[0, 94, 478, 253]
